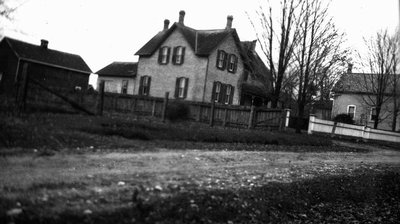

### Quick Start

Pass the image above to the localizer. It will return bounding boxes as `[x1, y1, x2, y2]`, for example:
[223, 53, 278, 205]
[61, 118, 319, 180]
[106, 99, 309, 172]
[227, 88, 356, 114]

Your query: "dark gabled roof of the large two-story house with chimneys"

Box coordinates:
[136, 23, 240, 56]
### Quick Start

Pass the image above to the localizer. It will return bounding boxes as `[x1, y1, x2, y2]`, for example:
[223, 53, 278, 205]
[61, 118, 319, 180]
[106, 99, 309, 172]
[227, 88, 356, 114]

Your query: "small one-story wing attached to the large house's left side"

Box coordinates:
[96, 62, 137, 95]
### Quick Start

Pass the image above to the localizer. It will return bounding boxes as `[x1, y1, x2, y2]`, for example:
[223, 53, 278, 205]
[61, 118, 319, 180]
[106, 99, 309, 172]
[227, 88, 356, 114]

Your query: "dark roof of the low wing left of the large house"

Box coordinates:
[96, 62, 137, 78]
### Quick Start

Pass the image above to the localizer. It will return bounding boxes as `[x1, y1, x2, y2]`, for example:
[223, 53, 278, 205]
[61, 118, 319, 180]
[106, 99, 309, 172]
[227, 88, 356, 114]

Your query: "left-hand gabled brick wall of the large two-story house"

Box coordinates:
[135, 30, 208, 101]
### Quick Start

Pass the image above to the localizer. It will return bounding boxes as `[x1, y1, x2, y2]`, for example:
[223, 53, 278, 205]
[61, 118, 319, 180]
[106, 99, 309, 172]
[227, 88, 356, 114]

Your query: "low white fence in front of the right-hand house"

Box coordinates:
[308, 115, 400, 142]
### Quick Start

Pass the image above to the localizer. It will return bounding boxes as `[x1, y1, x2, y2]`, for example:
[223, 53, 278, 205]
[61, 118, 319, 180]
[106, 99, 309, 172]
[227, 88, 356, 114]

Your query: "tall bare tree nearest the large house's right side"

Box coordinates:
[248, 0, 301, 108]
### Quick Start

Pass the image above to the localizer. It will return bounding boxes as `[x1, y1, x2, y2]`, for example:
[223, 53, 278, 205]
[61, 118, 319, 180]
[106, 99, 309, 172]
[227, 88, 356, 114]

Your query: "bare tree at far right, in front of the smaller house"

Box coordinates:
[360, 31, 398, 129]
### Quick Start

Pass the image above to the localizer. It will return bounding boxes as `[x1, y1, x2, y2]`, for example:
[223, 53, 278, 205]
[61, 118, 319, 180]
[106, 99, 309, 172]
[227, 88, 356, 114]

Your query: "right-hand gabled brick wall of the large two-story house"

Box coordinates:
[203, 35, 244, 105]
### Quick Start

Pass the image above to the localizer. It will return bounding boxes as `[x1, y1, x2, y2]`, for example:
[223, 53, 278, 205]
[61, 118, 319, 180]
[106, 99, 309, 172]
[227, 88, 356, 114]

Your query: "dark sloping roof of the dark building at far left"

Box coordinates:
[1, 37, 92, 74]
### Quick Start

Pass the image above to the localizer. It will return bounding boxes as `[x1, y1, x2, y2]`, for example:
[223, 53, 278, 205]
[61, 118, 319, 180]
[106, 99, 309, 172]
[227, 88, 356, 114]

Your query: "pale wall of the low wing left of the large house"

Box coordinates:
[97, 76, 136, 95]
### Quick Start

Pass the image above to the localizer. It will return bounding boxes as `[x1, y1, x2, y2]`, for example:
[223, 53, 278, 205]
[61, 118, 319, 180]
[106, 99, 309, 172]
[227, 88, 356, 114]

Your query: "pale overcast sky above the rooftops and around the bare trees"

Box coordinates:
[1, 0, 399, 75]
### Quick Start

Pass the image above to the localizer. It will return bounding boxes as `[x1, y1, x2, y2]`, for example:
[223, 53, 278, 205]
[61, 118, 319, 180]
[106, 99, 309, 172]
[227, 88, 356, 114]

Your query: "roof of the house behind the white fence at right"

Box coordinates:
[332, 73, 400, 94]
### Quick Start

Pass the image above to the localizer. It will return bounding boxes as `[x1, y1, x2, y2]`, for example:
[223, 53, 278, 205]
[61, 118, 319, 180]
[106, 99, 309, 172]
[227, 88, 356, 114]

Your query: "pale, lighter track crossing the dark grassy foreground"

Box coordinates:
[0, 145, 400, 223]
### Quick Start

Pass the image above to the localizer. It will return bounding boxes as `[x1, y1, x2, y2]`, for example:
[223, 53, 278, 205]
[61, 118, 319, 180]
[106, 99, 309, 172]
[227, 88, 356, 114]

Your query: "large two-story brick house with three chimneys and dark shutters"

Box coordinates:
[135, 11, 270, 105]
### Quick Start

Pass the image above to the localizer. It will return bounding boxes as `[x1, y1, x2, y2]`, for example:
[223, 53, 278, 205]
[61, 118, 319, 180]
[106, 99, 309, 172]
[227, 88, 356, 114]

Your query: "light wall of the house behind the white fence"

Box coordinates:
[332, 94, 400, 131]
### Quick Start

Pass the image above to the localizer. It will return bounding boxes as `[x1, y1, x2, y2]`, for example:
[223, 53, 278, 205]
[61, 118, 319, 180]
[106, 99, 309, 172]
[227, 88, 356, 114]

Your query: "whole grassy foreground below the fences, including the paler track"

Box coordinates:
[0, 113, 400, 223]
